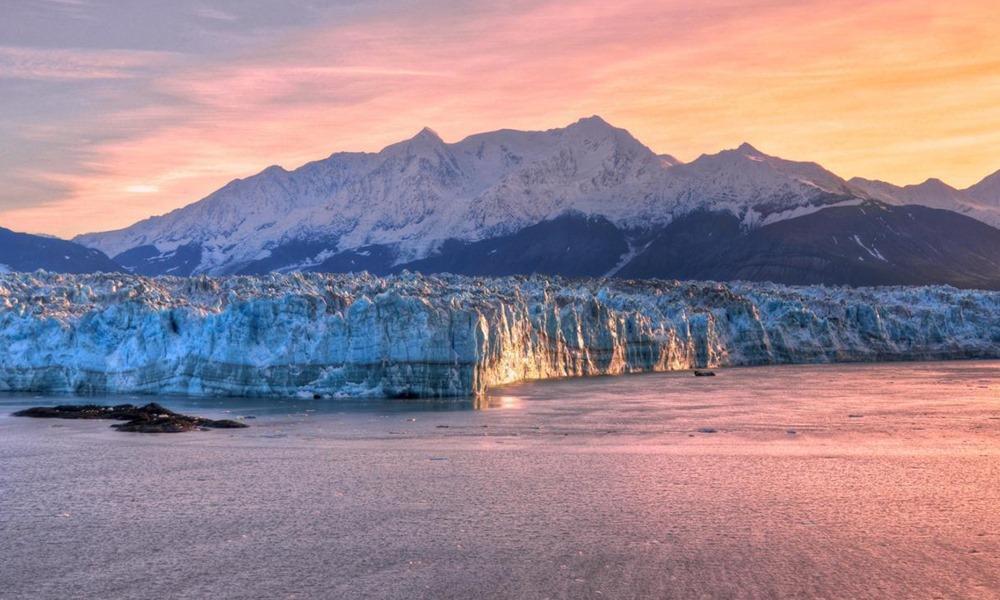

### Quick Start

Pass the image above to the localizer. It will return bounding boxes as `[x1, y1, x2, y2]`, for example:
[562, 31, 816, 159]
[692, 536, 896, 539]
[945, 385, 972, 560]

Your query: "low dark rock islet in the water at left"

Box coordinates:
[14, 402, 246, 433]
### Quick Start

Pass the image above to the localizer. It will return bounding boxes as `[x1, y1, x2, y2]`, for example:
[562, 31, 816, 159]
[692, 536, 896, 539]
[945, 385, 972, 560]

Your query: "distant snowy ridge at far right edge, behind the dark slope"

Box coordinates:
[849, 177, 1000, 227]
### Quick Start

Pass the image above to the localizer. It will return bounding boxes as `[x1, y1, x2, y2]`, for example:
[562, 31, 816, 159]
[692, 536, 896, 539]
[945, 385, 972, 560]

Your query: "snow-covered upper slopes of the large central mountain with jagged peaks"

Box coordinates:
[77, 117, 876, 274]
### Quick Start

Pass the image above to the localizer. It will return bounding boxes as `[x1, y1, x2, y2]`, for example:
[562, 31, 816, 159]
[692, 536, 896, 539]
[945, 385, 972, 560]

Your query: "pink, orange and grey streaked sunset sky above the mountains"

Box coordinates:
[0, 0, 1000, 236]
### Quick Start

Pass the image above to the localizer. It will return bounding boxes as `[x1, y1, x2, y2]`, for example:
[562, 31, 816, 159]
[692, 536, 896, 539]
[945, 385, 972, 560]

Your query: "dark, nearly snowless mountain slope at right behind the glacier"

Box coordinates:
[618, 202, 1000, 289]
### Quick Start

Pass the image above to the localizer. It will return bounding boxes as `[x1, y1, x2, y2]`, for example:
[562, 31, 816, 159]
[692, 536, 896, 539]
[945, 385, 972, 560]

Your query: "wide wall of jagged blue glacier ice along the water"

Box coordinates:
[0, 272, 1000, 397]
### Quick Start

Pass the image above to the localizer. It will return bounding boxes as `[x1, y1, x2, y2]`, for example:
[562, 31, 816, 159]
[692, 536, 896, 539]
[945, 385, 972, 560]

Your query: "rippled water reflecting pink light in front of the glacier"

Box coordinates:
[0, 361, 1000, 599]
